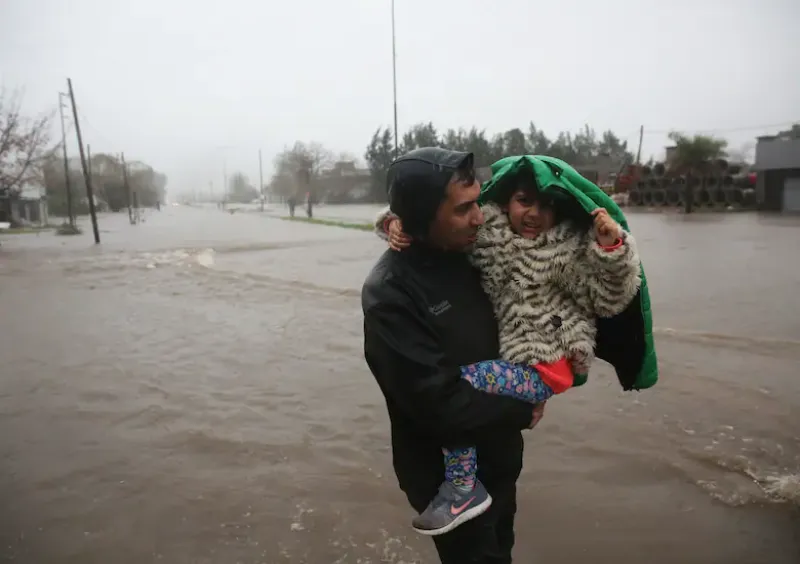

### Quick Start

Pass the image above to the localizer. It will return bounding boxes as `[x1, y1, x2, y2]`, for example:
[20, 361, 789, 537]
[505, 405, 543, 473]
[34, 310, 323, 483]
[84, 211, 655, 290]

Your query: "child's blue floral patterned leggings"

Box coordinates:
[442, 360, 553, 488]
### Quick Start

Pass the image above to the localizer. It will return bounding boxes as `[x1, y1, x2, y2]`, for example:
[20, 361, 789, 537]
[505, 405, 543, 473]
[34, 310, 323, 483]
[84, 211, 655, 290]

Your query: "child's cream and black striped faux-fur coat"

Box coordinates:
[375, 203, 641, 374]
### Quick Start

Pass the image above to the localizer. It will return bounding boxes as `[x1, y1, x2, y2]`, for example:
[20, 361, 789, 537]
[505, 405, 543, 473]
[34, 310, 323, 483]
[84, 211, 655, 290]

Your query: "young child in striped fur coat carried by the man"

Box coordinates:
[376, 156, 640, 535]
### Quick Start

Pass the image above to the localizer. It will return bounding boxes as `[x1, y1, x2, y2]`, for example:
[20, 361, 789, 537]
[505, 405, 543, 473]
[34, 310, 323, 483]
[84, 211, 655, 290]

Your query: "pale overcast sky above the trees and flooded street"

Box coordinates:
[0, 0, 800, 194]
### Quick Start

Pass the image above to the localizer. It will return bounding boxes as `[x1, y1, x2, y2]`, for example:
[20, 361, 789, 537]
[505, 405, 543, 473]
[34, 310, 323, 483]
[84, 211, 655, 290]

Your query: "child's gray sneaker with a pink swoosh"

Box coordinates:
[411, 480, 492, 536]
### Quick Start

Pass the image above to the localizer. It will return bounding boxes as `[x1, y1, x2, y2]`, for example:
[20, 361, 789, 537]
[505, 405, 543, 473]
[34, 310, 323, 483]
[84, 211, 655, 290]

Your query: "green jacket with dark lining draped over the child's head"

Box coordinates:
[480, 155, 658, 390]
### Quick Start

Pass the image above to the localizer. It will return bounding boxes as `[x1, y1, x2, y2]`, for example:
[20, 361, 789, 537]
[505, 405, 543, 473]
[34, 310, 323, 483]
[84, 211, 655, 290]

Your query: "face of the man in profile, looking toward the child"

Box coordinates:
[430, 173, 484, 251]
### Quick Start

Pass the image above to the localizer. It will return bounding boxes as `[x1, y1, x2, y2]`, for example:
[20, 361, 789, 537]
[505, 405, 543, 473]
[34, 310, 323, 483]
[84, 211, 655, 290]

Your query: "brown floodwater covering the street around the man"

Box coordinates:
[0, 207, 800, 564]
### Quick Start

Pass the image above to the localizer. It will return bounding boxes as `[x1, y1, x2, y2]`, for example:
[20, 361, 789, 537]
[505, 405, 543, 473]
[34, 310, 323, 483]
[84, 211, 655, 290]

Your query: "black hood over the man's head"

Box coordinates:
[386, 147, 473, 238]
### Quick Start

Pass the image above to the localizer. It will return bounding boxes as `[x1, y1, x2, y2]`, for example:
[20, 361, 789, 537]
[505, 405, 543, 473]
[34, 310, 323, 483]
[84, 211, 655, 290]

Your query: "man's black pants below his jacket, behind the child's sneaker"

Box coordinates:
[406, 482, 517, 564]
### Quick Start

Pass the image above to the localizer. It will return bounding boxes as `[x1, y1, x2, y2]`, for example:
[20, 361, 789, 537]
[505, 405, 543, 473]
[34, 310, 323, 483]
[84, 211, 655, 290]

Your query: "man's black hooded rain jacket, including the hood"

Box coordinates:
[361, 148, 533, 504]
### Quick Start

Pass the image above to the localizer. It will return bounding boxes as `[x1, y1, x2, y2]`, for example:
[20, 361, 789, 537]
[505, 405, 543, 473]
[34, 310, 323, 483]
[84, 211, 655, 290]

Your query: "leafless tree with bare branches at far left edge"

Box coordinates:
[0, 89, 52, 197]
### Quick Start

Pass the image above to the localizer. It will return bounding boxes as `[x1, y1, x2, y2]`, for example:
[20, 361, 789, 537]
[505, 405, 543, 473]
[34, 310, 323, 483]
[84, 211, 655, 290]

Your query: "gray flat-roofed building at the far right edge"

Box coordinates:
[753, 128, 800, 212]
